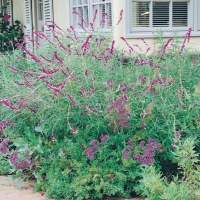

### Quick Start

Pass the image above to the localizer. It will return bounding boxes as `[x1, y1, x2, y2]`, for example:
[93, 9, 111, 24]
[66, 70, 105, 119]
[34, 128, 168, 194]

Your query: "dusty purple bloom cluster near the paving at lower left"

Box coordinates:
[10, 151, 33, 170]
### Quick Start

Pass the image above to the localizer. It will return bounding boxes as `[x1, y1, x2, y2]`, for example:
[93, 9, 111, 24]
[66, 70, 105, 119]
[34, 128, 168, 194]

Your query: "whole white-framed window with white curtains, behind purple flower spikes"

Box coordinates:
[69, 0, 112, 30]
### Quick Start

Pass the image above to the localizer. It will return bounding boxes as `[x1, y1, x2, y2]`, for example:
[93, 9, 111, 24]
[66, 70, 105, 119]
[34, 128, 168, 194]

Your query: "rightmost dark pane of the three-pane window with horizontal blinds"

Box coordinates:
[172, 2, 188, 27]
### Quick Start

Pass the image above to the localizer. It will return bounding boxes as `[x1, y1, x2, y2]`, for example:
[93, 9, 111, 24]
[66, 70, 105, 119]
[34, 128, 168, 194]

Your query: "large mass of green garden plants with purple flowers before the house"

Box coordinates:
[0, 9, 200, 199]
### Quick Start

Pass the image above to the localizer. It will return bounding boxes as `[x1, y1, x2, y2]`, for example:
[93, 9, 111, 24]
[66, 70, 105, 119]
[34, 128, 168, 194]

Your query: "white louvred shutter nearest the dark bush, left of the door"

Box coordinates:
[24, 0, 33, 42]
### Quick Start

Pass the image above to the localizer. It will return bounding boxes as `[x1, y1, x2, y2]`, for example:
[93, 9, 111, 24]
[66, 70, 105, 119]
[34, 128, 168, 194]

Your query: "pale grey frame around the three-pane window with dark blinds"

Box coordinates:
[125, 0, 200, 38]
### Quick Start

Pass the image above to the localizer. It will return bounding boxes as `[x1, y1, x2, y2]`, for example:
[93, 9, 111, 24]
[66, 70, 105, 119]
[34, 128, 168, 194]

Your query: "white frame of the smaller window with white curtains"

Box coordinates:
[67, 0, 113, 32]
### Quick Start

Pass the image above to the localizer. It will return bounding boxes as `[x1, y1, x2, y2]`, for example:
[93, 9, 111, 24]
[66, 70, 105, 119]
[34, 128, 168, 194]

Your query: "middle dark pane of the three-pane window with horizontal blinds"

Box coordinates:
[153, 2, 169, 27]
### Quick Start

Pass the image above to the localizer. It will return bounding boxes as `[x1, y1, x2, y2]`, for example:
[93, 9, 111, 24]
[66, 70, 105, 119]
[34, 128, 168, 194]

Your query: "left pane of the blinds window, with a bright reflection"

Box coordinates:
[132, 1, 149, 27]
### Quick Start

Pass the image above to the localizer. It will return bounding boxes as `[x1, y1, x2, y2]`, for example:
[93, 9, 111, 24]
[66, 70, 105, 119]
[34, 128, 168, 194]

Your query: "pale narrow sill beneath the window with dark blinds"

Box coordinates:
[125, 31, 200, 39]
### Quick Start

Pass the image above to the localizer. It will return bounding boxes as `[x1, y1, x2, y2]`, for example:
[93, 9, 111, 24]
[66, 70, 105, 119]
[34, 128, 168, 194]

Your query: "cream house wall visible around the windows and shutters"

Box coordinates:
[13, 0, 200, 52]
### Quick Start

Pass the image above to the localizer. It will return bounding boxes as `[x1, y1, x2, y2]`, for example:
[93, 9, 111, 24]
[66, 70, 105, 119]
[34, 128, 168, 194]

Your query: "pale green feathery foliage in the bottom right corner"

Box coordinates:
[136, 138, 200, 200]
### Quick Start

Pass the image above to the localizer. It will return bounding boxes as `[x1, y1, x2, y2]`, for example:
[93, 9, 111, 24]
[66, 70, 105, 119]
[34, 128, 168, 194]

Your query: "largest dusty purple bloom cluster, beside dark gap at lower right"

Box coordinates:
[133, 138, 162, 165]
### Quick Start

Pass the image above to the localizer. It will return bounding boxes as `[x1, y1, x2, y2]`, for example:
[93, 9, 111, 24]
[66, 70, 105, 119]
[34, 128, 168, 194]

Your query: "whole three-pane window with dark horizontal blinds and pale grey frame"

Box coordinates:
[126, 0, 200, 37]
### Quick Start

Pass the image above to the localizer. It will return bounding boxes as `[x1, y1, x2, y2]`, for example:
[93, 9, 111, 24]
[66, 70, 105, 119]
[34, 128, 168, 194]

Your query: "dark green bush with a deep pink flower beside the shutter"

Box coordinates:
[0, 3, 24, 53]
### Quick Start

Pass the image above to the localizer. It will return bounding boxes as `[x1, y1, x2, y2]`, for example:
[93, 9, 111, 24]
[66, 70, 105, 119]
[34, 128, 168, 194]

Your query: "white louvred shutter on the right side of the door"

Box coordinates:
[43, 0, 53, 38]
